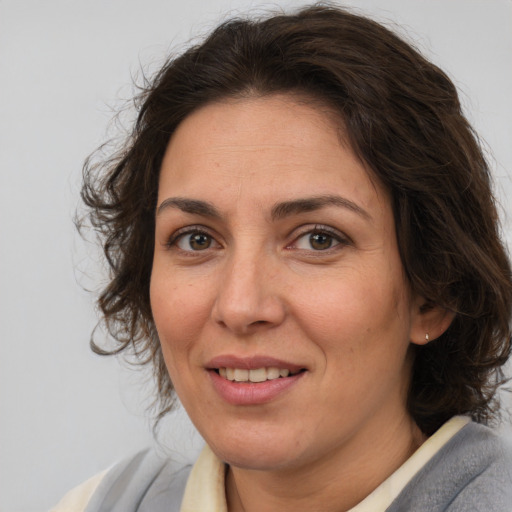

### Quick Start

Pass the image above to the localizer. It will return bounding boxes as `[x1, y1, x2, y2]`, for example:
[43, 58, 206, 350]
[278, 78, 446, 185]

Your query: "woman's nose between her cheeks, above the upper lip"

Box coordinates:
[212, 249, 286, 335]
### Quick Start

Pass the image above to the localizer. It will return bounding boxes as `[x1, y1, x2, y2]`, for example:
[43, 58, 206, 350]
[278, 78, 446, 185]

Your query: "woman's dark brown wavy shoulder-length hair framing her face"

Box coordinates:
[82, 5, 512, 434]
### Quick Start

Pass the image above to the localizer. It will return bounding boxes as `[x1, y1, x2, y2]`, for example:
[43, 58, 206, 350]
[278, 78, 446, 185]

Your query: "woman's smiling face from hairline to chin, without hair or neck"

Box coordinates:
[151, 96, 425, 469]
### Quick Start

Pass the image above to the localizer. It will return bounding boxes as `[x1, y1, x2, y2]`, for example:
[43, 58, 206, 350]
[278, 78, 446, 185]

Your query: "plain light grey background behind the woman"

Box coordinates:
[0, 0, 512, 512]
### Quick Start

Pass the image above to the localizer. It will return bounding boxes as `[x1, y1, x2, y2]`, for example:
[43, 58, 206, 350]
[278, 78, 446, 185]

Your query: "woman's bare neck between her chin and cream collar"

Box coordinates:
[226, 416, 425, 512]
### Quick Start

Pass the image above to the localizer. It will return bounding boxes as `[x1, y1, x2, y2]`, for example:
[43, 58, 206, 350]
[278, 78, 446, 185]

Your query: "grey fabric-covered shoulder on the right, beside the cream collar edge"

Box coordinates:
[388, 423, 512, 512]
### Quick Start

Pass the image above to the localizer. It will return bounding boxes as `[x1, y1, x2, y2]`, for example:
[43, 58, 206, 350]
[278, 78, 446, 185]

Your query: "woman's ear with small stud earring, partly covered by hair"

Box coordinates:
[410, 297, 455, 345]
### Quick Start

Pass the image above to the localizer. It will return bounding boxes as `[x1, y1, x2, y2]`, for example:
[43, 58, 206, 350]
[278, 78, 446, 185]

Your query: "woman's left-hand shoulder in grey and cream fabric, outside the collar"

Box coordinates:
[51, 450, 192, 512]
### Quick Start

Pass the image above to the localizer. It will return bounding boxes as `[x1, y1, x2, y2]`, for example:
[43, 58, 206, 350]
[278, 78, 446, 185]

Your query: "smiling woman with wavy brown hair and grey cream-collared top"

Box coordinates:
[53, 6, 512, 512]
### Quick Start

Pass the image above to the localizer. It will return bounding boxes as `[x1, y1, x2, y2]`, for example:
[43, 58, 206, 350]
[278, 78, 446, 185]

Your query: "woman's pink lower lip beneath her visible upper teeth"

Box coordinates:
[208, 370, 306, 405]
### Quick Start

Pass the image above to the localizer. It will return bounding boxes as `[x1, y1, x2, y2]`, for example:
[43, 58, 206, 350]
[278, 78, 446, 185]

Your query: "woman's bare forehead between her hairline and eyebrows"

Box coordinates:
[159, 95, 387, 215]
